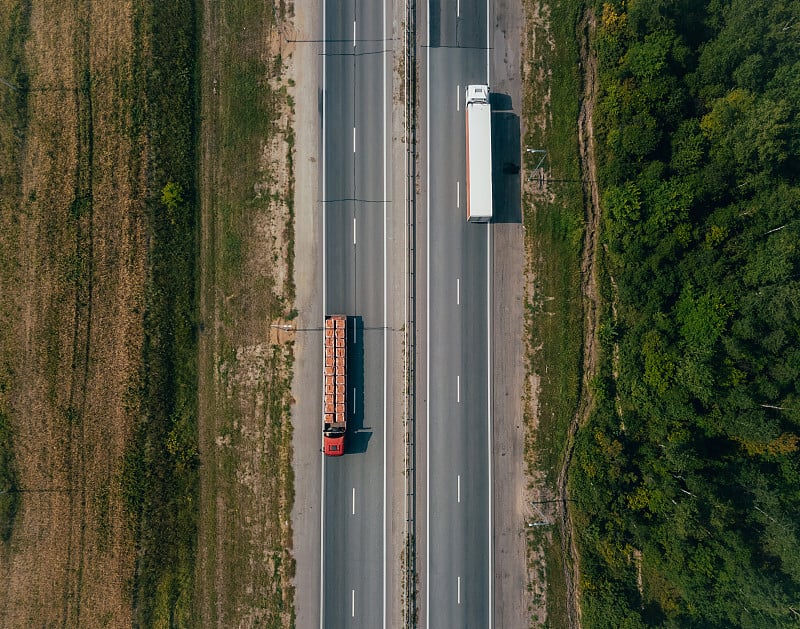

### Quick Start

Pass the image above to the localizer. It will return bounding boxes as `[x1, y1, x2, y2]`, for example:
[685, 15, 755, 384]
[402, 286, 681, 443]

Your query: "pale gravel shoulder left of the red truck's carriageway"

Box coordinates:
[292, 0, 323, 627]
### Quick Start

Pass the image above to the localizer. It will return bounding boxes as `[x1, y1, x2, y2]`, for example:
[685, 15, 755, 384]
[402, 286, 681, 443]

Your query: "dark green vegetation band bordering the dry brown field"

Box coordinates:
[122, 0, 198, 626]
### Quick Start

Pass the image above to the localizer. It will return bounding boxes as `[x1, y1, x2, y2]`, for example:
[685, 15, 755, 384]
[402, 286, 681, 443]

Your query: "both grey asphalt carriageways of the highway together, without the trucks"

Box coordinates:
[320, 0, 492, 629]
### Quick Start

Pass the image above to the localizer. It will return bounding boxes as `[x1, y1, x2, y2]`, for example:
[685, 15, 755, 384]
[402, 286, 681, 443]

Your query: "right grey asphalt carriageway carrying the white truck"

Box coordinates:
[422, 0, 492, 629]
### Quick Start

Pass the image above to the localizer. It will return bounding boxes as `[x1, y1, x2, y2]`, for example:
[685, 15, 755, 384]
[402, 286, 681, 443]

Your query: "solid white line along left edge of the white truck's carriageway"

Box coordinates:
[425, 6, 432, 629]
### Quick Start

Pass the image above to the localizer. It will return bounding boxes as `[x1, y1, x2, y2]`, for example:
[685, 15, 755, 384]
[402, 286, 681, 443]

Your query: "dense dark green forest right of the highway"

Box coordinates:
[570, 0, 800, 627]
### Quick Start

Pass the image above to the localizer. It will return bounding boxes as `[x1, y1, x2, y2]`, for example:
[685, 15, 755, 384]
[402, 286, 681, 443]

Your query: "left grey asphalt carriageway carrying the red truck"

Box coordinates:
[320, 0, 392, 629]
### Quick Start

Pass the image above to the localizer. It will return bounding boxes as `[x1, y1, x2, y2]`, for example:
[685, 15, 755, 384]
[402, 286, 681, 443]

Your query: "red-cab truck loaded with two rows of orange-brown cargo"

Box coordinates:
[322, 315, 347, 456]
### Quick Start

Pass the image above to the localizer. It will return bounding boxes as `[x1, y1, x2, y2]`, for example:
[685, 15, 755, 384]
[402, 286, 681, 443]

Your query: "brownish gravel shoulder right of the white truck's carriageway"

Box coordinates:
[491, 0, 531, 628]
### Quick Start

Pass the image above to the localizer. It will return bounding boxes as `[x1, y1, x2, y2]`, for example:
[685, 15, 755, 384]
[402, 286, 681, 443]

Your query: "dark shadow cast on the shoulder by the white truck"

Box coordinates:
[490, 92, 522, 223]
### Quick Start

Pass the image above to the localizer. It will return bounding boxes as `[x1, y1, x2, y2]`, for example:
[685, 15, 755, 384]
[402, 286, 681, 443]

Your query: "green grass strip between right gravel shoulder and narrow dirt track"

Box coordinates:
[523, 0, 585, 627]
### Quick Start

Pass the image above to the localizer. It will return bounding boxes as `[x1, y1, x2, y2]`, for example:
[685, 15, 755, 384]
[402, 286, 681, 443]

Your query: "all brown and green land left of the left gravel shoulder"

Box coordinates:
[5, 0, 304, 627]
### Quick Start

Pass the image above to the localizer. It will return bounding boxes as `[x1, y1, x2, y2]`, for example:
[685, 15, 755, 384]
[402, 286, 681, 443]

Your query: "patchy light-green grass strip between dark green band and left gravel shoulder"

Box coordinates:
[196, 0, 295, 627]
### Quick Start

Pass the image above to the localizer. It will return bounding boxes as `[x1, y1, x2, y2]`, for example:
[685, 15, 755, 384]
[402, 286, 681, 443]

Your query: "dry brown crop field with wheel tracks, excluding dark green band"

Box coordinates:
[0, 0, 146, 627]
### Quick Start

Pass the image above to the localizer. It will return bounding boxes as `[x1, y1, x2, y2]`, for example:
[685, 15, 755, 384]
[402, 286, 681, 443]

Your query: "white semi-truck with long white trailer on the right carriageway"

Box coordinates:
[466, 85, 492, 223]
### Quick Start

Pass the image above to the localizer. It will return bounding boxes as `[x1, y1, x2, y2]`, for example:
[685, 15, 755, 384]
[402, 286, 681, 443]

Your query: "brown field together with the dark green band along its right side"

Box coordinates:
[0, 0, 208, 627]
